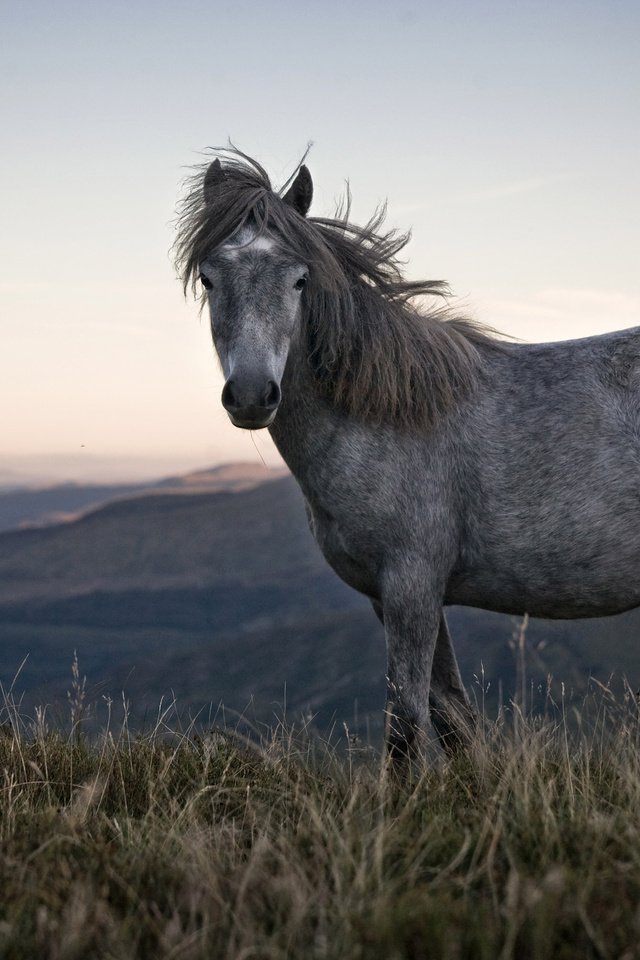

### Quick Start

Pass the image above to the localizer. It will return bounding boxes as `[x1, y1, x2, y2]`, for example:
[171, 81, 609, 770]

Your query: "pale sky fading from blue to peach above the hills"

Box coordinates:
[0, 0, 640, 484]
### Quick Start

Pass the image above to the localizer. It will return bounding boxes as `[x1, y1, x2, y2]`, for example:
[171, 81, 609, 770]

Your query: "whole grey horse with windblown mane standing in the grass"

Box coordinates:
[175, 150, 640, 767]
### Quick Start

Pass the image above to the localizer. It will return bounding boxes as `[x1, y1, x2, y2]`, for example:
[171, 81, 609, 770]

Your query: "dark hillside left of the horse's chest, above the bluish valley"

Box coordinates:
[0, 478, 321, 603]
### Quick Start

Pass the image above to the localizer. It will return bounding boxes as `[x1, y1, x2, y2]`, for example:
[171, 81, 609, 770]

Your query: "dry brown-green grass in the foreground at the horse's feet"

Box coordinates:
[0, 676, 640, 960]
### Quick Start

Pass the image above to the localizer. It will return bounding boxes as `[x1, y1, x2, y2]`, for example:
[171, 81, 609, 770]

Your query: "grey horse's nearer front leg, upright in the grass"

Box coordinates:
[376, 583, 442, 769]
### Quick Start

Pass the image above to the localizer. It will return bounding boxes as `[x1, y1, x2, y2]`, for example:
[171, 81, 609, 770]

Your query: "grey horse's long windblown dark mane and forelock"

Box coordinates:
[174, 150, 500, 426]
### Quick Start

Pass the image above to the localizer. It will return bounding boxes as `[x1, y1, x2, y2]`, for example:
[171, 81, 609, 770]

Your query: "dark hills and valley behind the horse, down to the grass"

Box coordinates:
[0, 467, 640, 732]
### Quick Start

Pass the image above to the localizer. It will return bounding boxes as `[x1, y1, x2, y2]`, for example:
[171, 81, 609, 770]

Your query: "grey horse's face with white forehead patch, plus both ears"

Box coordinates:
[200, 160, 313, 430]
